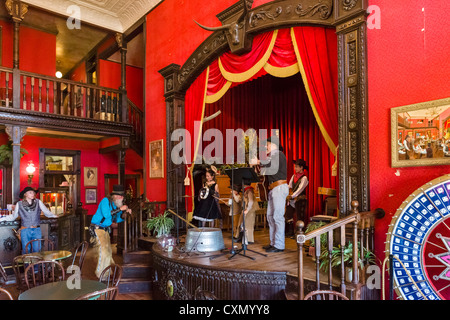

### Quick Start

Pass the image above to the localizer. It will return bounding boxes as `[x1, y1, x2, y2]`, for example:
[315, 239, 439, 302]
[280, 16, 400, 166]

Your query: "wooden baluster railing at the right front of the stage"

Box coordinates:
[297, 201, 385, 300]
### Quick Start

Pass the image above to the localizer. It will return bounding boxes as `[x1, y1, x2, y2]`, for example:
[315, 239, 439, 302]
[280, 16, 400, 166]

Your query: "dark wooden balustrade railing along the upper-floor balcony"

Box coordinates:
[0, 67, 135, 124]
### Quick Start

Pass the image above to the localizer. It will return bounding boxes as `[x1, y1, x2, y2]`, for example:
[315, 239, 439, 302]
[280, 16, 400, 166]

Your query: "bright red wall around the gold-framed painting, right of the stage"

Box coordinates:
[367, 0, 450, 259]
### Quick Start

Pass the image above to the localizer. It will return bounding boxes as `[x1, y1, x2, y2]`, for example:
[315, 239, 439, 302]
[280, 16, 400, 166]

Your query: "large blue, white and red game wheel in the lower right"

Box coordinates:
[386, 174, 450, 300]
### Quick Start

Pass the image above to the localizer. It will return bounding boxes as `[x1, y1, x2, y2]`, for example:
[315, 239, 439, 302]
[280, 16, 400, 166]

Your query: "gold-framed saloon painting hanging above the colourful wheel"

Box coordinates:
[391, 98, 450, 168]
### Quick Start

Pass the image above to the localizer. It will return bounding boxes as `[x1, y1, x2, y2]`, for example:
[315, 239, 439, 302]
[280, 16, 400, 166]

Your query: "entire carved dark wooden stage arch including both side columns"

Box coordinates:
[159, 0, 370, 215]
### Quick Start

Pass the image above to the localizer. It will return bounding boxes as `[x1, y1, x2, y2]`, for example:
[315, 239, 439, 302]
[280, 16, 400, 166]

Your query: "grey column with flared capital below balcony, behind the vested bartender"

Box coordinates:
[5, 125, 27, 203]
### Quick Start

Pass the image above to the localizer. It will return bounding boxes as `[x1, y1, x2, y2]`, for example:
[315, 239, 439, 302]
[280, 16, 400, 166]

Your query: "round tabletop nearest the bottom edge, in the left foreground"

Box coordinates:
[19, 280, 107, 300]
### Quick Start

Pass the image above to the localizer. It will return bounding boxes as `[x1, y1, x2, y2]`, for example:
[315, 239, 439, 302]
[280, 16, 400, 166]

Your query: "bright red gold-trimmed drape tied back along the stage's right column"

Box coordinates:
[293, 27, 338, 153]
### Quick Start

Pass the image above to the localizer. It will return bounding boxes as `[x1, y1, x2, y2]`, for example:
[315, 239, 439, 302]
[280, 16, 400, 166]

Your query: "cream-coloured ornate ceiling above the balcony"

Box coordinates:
[22, 0, 163, 33]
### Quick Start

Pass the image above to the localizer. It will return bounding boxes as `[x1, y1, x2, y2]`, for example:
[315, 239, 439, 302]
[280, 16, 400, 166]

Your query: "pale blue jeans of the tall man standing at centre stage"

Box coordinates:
[267, 184, 289, 250]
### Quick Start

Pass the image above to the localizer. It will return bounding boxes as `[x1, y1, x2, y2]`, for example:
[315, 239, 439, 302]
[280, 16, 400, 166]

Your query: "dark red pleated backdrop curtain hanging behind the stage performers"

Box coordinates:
[203, 73, 336, 223]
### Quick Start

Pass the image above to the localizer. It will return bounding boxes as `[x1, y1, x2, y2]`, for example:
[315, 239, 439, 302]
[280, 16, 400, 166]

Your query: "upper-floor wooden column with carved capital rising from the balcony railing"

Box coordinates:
[5, 0, 28, 109]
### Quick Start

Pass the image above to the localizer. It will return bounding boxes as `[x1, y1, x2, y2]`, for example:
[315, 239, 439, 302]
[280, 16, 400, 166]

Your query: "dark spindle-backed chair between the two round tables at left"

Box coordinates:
[24, 261, 66, 289]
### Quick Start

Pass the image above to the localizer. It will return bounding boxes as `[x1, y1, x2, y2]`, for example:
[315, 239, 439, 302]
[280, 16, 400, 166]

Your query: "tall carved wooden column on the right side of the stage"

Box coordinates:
[335, 0, 369, 215]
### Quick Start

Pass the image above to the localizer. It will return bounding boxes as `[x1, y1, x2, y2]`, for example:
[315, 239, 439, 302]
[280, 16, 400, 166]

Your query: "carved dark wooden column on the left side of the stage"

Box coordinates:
[159, 64, 186, 216]
